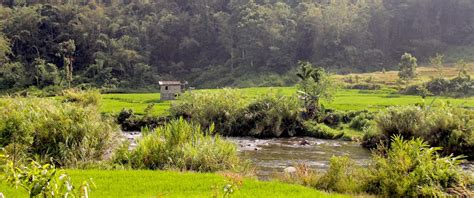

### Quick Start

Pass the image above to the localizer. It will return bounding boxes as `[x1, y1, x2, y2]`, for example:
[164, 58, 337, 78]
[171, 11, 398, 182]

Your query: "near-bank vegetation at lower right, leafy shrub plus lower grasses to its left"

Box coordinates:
[283, 136, 472, 197]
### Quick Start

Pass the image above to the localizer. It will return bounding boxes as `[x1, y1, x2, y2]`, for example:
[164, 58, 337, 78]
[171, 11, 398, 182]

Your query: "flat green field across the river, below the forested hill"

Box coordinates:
[101, 87, 474, 115]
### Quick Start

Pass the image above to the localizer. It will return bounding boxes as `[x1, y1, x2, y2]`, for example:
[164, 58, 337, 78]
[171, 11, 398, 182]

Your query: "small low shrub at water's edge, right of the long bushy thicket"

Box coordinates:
[303, 121, 344, 139]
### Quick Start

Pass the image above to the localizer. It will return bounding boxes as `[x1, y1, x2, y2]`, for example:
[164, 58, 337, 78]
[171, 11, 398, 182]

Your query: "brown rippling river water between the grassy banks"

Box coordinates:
[227, 137, 370, 179]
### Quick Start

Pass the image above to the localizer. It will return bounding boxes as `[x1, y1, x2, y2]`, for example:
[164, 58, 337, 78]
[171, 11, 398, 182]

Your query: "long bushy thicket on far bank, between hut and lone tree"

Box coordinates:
[170, 89, 301, 137]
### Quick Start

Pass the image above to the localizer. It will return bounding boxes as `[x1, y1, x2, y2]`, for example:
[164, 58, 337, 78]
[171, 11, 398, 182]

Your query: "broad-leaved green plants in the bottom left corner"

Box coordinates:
[3, 158, 94, 198]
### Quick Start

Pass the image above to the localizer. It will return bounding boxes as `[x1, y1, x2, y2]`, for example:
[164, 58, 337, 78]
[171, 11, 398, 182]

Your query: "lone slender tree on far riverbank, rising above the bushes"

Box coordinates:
[297, 62, 337, 118]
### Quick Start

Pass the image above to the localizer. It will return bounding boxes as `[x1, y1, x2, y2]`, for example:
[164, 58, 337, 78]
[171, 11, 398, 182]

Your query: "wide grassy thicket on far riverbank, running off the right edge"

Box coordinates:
[364, 106, 474, 158]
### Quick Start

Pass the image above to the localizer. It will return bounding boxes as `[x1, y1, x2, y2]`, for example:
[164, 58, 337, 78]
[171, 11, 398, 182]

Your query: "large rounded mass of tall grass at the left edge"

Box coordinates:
[0, 93, 118, 166]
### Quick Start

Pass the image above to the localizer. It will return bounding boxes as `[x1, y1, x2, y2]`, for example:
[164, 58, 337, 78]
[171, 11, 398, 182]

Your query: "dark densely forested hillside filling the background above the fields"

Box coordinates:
[0, 0, 474, 89]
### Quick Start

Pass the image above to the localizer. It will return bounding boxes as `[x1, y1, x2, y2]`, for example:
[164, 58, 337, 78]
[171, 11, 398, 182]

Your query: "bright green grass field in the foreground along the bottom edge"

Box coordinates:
[0, 170, 344, 198]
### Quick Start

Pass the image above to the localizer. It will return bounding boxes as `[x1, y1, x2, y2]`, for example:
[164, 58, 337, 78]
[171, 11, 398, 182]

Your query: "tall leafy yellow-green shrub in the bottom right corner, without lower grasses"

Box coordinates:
[367, 136, 469, 197]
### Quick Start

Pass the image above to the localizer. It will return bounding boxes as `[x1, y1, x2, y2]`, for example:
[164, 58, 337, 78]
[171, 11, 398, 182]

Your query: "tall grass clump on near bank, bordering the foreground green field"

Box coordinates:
[114, 119, 239, 172]
